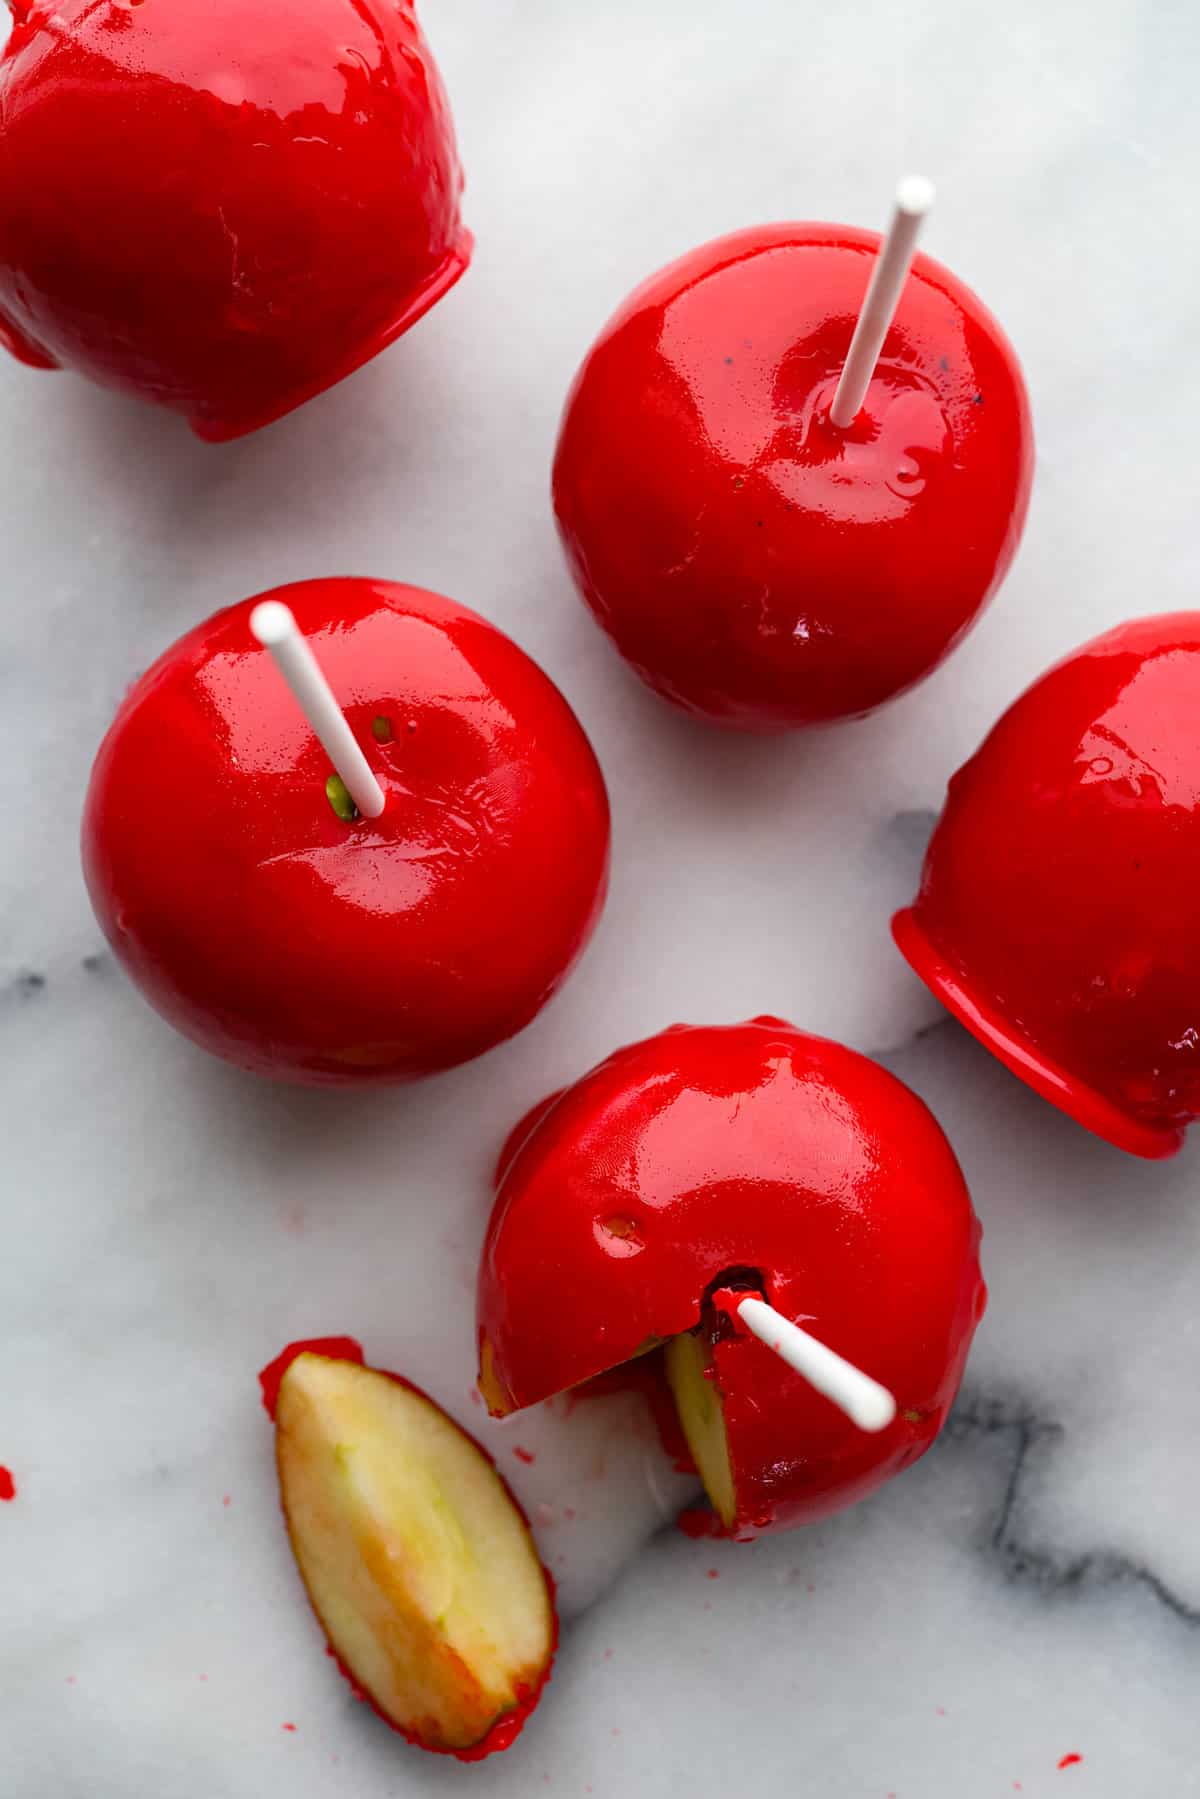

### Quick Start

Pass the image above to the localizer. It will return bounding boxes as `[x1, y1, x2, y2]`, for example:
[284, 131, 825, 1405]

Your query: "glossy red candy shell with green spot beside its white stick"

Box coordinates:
[83, 579, 608, 1085]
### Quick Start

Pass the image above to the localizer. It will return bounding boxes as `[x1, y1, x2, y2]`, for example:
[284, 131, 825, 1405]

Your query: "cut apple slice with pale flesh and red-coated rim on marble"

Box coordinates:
[264, 1346, 558, 1759]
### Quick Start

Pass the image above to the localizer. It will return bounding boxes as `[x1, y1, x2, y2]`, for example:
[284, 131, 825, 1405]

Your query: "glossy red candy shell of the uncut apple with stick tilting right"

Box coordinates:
[554, 225, 1033, 730]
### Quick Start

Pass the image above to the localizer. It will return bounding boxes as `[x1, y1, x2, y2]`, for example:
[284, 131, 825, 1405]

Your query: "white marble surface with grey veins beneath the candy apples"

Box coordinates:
[0, 0, 1200, 1799]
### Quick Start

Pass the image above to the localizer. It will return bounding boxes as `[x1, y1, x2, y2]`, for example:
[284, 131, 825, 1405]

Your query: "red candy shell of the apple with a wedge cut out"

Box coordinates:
[479, 1018, 986, 1536]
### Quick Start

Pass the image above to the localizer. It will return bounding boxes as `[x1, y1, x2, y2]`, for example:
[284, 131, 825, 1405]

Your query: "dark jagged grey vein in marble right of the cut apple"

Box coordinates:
[946, 1394, 1200, 1630]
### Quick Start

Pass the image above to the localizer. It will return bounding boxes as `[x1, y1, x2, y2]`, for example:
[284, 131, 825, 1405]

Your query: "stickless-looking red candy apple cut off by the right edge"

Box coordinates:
[892, 612, 1200, 1157]
